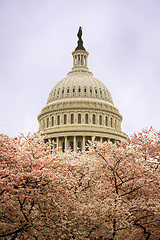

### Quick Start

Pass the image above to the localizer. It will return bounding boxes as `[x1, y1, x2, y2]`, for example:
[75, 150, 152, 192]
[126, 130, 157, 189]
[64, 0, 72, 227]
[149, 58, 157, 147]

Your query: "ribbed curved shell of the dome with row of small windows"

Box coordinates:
[47, 71, 113, 104]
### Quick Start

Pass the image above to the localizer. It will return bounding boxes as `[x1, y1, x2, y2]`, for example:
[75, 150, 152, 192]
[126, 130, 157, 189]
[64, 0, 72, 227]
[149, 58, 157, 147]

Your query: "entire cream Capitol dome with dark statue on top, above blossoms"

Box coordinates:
[38, 28, 127, 151]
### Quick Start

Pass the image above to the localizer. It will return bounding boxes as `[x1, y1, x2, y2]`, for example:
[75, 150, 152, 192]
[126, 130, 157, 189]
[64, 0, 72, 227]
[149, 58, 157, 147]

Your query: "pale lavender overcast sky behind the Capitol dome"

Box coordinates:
[0, 0, 160, 137]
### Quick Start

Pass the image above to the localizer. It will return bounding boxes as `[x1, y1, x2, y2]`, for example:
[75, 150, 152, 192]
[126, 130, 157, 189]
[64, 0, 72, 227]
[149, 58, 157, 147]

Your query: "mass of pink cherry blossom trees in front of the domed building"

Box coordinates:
[0, 130, 160, 240]
